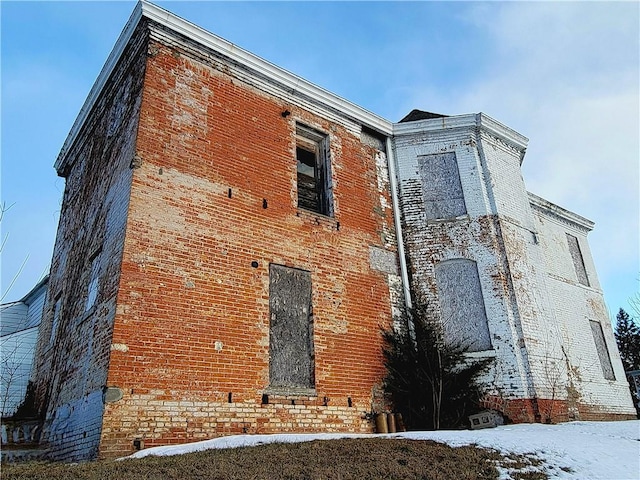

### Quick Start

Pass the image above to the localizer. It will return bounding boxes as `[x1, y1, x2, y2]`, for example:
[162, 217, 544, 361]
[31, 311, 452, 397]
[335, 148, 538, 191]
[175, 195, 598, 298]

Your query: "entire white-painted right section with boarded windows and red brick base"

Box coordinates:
[394, 114, 635, 422]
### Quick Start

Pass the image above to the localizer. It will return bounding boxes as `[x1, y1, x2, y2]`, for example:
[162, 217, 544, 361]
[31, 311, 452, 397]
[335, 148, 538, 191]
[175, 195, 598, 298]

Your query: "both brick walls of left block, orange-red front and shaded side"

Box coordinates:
[30, 4, 399, 459]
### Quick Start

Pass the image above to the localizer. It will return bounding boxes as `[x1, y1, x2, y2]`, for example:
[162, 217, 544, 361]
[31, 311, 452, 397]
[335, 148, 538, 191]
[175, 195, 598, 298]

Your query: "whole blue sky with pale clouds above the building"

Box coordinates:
[0, 1, 640, 313]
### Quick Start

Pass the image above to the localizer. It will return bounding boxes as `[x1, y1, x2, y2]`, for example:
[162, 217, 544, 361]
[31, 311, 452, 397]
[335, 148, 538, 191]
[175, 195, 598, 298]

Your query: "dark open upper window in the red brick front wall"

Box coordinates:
[296, 125, 333, 216]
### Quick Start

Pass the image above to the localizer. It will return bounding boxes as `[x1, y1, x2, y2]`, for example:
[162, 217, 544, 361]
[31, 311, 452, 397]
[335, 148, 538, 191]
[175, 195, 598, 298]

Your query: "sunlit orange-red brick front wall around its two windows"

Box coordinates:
[101, 39, 392, 456]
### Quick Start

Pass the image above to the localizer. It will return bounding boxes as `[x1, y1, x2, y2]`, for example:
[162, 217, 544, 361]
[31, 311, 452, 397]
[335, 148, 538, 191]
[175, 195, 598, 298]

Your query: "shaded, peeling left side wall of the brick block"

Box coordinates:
[35, 24, 146, 458]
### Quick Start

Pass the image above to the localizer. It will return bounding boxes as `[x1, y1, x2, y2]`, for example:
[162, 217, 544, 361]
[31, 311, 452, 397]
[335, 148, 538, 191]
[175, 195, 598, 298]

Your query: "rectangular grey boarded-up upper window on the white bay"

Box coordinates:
[418, 152, 467, 220]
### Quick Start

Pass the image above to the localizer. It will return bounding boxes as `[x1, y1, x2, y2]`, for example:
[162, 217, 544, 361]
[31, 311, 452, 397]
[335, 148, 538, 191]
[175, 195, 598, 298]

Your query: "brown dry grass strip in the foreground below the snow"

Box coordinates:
[2, 438, 547, 480]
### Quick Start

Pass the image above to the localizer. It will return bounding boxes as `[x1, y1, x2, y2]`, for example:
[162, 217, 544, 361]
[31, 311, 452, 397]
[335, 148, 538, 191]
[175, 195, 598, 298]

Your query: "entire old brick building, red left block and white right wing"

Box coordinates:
[34, 2, 634, 459]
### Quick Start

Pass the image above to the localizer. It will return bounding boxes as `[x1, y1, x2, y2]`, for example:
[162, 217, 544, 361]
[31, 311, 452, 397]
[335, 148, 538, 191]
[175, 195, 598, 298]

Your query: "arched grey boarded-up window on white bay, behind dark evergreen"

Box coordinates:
[436, 258, 491, 352]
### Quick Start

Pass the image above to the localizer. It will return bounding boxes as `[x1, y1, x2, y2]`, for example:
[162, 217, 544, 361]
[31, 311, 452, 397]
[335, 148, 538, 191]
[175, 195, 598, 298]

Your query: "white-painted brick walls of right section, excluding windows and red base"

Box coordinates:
[395, 116, 633, 414]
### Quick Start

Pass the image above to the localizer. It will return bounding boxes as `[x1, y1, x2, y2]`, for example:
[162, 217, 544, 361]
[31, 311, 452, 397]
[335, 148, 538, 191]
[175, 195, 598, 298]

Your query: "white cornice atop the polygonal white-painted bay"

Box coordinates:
[393, 113, 529, 151]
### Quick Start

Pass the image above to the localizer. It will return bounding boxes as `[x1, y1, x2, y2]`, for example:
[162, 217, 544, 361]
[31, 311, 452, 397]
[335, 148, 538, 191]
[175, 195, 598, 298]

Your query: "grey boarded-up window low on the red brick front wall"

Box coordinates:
[269, 265, 315, 388]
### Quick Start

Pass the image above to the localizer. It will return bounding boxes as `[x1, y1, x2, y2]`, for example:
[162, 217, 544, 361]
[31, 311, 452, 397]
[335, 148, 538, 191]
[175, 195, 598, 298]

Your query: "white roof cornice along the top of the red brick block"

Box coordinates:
[54, 0, 392, 170]
